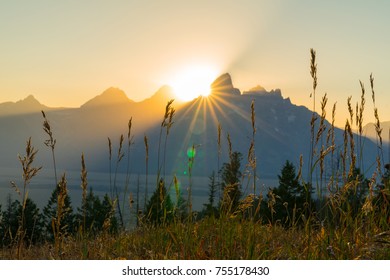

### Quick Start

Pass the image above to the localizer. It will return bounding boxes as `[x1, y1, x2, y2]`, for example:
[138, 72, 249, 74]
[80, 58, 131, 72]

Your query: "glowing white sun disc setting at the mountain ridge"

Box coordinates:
[169, 65, 217, 101]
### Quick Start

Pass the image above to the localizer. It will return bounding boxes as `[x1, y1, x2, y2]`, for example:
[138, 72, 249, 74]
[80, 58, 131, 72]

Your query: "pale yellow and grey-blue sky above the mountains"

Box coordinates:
[0, 0, 390, 125]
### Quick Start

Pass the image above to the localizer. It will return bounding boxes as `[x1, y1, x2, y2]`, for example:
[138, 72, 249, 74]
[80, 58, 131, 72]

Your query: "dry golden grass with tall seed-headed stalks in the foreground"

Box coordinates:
[1, 49, 390, 259]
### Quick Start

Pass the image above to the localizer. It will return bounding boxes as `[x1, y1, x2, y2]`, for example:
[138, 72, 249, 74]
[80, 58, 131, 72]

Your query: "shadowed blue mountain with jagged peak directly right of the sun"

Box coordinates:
[121, 74, 376, 178]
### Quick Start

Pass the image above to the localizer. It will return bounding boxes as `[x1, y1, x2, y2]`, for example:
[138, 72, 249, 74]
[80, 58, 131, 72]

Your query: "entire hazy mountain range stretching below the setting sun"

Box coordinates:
[0, 73, 386, 187]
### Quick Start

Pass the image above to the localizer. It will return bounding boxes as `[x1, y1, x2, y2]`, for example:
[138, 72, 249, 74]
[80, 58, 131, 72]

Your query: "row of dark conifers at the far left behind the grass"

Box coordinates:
[0, 187, 119, 247]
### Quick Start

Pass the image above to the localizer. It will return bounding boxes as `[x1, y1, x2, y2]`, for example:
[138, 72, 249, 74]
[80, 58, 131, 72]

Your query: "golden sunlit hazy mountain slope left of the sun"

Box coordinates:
[0, 87, 178, 170]
